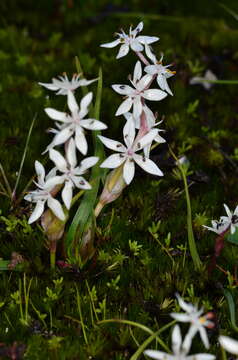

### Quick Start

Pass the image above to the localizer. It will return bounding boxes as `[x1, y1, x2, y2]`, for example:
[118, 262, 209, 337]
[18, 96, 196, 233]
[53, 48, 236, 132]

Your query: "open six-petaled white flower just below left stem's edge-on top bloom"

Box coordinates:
[45, 91, 107, 155]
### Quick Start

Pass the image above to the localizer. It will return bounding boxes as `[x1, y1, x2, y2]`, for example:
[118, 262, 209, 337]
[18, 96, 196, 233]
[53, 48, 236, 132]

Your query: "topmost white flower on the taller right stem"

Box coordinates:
[100, 22, 159, 59]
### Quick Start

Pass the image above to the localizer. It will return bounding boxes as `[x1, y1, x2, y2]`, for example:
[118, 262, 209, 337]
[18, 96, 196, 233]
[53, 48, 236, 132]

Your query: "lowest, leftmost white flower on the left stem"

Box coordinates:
[24, 161, 65, 224]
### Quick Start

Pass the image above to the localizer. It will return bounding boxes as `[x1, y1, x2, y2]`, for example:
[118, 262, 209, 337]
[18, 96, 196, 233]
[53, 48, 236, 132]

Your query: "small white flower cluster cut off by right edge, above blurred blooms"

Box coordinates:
[203, 204, 238, 235]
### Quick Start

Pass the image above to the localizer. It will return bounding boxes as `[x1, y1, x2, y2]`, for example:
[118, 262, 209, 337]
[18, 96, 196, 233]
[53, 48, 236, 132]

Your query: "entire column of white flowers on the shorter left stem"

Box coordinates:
[25, 74, 107, 224]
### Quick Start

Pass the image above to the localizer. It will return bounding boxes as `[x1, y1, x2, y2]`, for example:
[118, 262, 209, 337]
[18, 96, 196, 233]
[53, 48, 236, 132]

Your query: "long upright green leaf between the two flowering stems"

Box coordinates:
[66, 68, 105, 257]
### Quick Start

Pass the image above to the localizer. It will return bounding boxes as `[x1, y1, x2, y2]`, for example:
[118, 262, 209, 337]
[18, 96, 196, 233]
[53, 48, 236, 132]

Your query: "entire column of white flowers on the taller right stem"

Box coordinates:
[99, 22, 175, 185]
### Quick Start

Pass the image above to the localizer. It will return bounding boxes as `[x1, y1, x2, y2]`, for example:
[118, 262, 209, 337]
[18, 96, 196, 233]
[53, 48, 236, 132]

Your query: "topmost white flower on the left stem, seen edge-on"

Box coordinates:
[38, 74, 98, 95]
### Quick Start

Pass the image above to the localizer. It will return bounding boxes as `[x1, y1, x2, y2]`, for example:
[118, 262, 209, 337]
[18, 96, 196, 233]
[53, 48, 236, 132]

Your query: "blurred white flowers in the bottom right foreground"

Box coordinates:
[145, 295, 215, 360]
